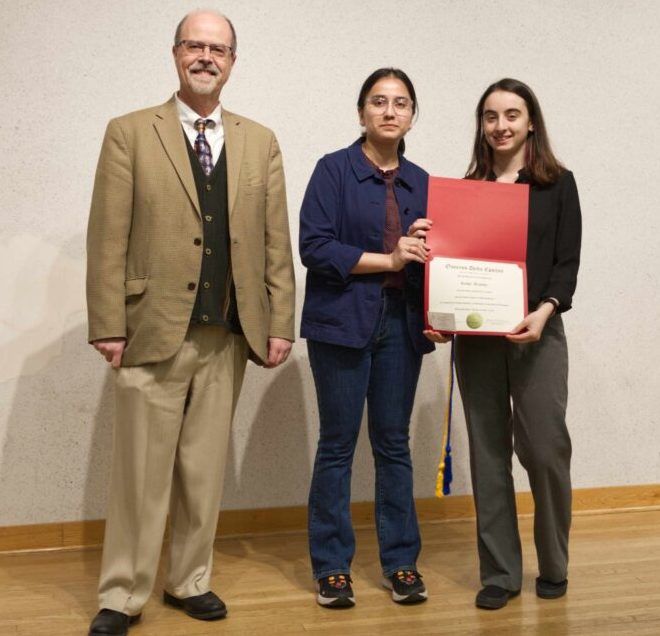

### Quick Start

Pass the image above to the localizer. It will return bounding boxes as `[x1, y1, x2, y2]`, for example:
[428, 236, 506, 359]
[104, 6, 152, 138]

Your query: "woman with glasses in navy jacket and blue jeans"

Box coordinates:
[300, 68, 433, 607]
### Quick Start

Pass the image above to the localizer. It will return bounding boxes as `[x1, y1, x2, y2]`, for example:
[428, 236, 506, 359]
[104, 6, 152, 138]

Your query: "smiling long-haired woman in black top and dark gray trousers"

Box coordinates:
[426, 79, 581, 609]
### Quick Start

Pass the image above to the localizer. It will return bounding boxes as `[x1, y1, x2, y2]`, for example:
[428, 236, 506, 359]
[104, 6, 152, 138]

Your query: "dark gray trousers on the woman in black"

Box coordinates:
[456, 316, 571, 591]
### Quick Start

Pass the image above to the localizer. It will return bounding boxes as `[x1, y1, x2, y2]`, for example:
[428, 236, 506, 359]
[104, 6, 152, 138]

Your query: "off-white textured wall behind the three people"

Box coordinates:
[0, 0, 660, 525]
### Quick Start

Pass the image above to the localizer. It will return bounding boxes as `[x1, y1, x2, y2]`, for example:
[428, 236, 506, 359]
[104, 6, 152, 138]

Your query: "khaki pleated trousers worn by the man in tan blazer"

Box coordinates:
[99, 326, 248, 616]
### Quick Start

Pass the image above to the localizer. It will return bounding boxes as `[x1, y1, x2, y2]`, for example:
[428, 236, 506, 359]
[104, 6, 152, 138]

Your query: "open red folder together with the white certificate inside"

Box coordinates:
[425, 177, 529, 335]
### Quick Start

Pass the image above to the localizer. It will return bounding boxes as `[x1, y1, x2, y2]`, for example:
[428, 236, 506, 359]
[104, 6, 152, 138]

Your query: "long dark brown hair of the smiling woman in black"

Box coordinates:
[465, 77, 565, 186]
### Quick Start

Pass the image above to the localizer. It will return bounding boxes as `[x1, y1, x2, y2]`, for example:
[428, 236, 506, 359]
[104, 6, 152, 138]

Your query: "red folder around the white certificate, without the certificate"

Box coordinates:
[424, 177, 529, 335]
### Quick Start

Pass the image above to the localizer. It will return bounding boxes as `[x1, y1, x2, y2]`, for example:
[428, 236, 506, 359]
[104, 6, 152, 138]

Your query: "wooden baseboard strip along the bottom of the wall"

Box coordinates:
[0, 484, 660, 552]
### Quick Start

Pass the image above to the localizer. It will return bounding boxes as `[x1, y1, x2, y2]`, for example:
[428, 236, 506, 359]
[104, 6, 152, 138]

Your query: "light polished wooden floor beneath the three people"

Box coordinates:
[0, 510, 660, 636]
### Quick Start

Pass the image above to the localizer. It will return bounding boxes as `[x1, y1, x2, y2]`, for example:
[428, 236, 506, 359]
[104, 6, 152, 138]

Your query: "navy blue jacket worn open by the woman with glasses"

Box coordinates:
[300, 140, 433, 353]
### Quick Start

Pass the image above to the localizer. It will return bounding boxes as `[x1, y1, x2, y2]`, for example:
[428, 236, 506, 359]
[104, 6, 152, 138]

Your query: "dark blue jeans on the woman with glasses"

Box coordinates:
[307, 293, 422, 579]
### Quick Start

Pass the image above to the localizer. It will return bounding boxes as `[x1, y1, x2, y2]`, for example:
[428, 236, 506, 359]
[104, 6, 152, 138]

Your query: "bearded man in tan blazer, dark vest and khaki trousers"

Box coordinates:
[87, 11, 294, 635]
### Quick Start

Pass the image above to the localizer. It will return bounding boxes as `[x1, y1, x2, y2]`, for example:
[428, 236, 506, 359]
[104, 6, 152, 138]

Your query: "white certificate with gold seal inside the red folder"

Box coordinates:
[427, 257, 526, 333]
